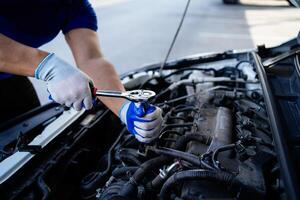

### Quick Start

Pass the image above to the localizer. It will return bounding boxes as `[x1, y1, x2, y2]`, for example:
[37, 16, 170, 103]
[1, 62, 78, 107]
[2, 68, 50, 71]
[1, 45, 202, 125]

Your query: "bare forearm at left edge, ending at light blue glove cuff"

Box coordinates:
[0, 34, 48, 76]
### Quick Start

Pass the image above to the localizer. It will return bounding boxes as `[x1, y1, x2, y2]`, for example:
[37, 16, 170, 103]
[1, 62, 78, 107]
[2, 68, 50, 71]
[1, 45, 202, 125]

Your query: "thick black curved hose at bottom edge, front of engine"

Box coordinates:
[159, 170, 235, 200]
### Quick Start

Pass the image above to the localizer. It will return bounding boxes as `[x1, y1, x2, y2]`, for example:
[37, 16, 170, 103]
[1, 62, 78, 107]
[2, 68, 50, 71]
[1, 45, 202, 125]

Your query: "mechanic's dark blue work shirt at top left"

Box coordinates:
[0, 0, 97, 79]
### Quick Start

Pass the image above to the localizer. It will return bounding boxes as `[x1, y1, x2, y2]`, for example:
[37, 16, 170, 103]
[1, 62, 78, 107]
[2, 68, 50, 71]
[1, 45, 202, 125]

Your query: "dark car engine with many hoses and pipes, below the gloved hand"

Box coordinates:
[81, 59, 281, 200]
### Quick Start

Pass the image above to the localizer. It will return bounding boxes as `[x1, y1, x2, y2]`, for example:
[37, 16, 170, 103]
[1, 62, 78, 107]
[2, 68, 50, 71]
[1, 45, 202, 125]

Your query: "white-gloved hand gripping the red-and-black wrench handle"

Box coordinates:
[35, 53, 93, 111]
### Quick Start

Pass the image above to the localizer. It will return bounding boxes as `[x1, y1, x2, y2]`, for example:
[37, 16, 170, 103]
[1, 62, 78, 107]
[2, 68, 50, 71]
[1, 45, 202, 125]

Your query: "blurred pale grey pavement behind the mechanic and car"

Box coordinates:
[32, 0, 300, 104]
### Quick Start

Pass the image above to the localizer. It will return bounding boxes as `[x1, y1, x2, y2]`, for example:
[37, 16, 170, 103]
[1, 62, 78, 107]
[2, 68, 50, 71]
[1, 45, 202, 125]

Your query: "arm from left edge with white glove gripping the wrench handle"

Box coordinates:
[0, 34, 93, 110]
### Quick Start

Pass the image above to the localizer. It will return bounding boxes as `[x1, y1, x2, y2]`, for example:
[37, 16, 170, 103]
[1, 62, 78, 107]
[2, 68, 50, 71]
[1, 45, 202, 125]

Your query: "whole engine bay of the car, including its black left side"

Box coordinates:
[0, 53, 283, 200]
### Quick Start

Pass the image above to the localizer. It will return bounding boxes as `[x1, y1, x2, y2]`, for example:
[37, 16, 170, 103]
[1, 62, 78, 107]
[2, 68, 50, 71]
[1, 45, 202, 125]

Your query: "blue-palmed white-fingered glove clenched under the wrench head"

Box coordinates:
[119, 101, 163, 143]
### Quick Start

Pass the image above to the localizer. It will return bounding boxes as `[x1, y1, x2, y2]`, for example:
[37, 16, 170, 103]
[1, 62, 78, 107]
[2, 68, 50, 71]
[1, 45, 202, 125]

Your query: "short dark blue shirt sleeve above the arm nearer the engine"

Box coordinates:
[62, 0, 98, 34]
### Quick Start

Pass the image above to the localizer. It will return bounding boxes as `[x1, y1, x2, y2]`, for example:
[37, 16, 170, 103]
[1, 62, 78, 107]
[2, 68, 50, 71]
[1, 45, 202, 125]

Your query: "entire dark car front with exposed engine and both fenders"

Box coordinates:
[0, 36, 300, 200]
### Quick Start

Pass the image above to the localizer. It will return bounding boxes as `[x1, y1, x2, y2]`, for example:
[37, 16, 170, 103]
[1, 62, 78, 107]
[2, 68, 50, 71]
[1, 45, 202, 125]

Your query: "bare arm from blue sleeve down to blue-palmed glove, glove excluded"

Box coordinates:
[65, 29, 125, 115]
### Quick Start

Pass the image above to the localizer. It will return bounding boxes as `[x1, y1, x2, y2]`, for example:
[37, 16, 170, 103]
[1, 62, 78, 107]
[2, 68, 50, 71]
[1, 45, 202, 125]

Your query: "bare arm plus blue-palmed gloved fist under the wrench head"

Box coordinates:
[66, 29, 162, 142]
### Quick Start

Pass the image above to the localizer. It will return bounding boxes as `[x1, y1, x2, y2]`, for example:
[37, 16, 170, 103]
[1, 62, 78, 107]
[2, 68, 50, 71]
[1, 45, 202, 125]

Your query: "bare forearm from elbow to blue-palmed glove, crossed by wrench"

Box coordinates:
[78, 57, 125, 115]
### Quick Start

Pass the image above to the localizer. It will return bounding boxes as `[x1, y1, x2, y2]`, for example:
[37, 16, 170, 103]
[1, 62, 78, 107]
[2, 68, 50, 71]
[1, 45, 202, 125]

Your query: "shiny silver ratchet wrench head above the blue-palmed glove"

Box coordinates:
[124, 90, 156, 102]
